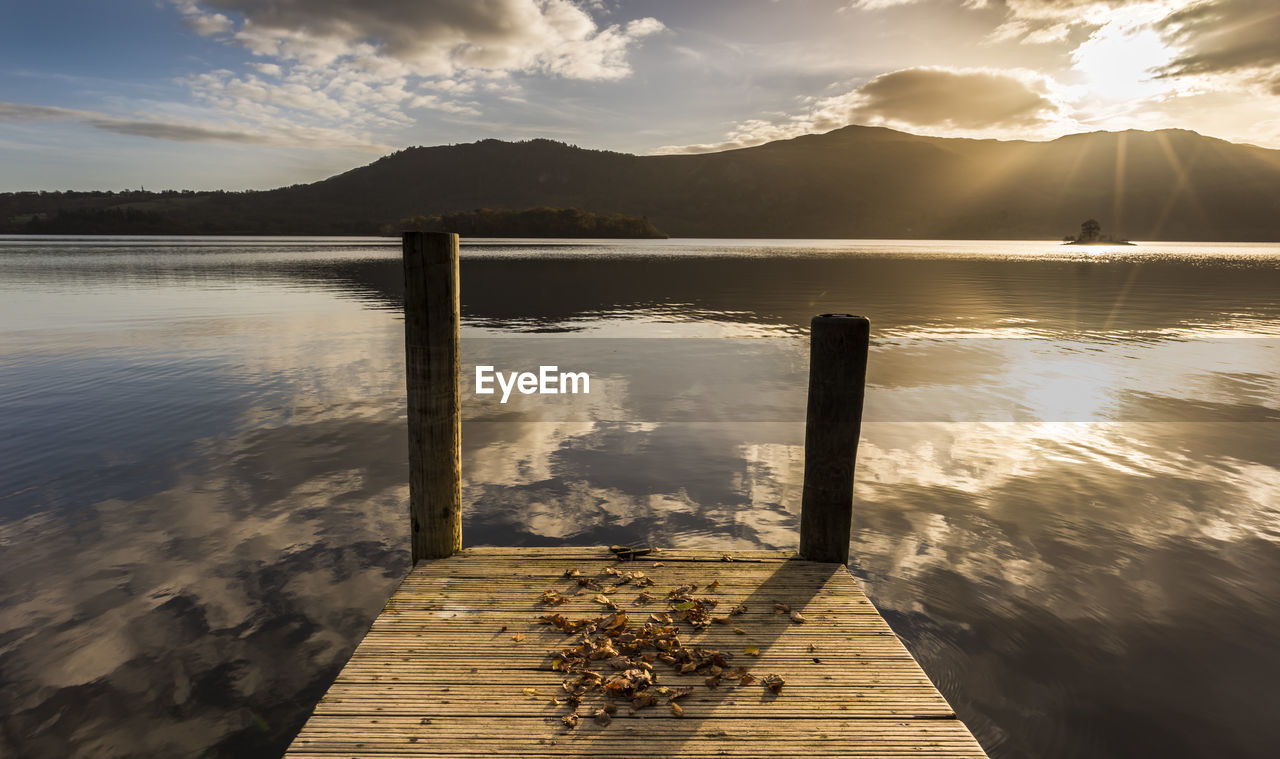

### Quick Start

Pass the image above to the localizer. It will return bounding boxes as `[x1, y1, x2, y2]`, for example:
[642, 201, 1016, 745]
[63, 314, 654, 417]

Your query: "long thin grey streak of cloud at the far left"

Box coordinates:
[0, 102, 389, 152]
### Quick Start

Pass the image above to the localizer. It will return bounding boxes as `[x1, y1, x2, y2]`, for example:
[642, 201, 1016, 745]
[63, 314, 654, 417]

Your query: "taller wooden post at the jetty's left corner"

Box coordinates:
[403, 232, 462, 564]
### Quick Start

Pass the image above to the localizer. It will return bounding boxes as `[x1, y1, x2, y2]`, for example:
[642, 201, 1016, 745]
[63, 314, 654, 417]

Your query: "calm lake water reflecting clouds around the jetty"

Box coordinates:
[0, 238, 1280, 758]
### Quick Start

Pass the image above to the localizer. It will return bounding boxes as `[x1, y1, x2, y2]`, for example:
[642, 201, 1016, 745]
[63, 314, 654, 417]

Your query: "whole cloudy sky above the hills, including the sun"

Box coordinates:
[0, 0, 1280, 191]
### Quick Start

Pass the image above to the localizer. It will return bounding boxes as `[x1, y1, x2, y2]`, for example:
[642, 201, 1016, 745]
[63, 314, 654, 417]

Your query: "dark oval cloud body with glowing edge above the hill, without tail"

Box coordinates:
[850, 68, 1059, 129]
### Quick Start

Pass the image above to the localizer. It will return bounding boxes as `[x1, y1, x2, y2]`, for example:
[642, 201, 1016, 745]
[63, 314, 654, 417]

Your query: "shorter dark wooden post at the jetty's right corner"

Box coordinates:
[800, 314, 870, 564]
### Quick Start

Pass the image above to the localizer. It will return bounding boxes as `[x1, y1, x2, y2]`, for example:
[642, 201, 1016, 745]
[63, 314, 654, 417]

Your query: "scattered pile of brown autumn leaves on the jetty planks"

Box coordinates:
[539, 567, 785, 728]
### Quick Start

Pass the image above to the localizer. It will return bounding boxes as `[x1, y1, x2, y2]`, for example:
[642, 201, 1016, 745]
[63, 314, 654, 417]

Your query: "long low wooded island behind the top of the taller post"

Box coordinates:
[389, 207, 667, 239]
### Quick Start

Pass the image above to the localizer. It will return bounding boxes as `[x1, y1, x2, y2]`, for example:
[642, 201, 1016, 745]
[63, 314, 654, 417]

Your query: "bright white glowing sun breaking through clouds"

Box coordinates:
[1071, 19, 1174, 101]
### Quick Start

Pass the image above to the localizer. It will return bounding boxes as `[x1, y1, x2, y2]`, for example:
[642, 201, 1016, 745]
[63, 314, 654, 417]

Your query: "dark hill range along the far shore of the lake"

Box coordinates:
[0, 127, 1280, 241]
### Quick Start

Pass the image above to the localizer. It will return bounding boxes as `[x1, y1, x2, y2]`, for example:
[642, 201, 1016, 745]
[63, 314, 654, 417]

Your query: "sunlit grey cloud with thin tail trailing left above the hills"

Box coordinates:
[655, 67, 1074, 154]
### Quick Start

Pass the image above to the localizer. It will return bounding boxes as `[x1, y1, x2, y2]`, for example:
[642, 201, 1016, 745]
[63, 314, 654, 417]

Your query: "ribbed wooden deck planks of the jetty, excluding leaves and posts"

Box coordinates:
[287, 548, 986, 759]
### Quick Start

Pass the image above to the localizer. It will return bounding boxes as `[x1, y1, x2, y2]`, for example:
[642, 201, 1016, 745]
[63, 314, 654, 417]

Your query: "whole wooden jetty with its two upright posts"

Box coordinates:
[287, 233, 986, 759]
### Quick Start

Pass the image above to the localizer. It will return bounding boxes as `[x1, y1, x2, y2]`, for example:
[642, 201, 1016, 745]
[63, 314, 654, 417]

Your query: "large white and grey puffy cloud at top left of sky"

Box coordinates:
[156, 0, 666, 157]
